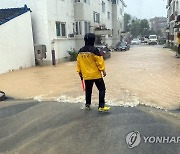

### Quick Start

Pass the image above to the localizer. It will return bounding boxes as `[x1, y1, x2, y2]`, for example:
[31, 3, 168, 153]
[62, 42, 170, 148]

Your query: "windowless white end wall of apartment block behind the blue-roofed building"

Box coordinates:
[0, 0, 51, 59]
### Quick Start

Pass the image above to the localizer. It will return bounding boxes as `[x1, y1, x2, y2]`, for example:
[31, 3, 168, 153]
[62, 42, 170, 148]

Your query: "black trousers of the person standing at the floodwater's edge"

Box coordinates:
[85, 78, 106, 107]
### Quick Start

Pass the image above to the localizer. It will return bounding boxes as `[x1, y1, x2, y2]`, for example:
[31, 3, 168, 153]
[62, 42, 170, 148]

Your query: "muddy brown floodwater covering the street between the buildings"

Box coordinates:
[0, 46, 180, 109]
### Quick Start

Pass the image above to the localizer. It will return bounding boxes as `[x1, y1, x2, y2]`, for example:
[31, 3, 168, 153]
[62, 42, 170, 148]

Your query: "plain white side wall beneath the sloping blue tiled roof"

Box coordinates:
[0, 12, 35, 74]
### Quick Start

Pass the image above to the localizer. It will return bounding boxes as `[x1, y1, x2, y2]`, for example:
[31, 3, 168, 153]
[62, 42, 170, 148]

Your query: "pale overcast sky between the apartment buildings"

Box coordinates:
[124, 0, 167, 19]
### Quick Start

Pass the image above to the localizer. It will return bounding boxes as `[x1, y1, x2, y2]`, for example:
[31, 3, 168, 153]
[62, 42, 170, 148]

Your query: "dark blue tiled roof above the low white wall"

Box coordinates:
[0, 5, 31, 25]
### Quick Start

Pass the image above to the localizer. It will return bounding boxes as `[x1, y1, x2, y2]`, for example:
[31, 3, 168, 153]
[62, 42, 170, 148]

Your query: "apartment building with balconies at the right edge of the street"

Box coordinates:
[166, 0, 180, 45]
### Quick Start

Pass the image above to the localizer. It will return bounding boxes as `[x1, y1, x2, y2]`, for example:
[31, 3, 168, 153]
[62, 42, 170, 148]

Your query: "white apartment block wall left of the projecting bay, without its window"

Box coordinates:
[0, 0, 76, 63]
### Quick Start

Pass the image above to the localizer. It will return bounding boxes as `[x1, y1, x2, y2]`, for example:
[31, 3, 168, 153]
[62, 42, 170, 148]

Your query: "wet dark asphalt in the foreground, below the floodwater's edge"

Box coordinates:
[0, 100, 180, 154]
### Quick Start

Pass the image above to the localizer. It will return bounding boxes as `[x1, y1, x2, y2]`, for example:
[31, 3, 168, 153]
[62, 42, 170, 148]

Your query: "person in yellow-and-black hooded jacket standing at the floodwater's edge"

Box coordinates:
[77, 33, 110, 112]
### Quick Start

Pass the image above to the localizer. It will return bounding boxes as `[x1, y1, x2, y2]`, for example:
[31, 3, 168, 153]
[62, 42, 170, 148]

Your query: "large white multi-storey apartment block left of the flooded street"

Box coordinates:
[0, 0, 125, 63]
